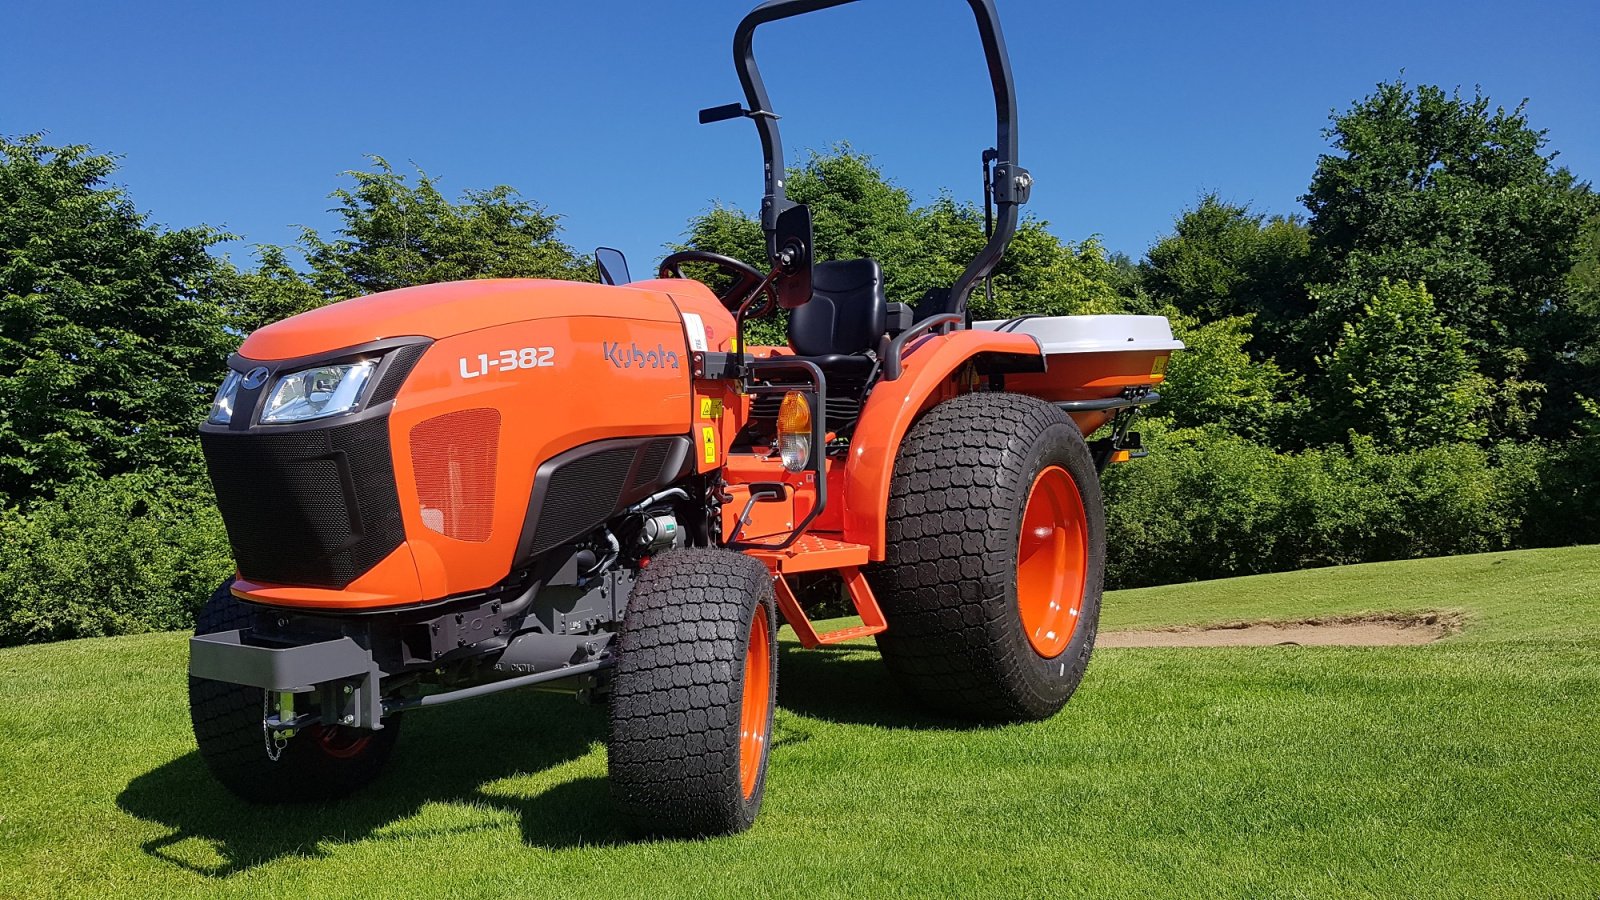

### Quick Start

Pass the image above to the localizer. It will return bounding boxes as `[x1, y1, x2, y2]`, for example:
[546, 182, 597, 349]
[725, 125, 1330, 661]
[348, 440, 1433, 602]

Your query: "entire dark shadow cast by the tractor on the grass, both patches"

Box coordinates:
[117, 642, 978, 878]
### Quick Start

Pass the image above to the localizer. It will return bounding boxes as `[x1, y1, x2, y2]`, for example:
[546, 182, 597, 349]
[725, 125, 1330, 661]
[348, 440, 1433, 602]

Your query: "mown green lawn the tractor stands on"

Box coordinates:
[0, 548, 1600, 900]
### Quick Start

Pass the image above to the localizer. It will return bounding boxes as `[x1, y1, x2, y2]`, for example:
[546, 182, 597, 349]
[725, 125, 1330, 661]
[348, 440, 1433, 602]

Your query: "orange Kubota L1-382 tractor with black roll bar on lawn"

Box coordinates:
[189, 0, 1181, 834]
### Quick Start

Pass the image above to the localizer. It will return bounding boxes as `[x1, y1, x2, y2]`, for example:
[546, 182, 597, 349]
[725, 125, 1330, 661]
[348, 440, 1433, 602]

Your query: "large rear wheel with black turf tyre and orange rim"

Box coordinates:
[869, 392, 1106, 721]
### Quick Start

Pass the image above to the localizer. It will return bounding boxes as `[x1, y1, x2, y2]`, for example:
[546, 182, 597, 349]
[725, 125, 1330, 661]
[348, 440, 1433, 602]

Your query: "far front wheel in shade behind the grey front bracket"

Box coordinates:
[189, 581, 400, 802]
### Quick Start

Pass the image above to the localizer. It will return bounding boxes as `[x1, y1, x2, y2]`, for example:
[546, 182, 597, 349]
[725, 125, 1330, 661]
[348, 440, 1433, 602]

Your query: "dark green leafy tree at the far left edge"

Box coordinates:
[0, 135, 235, 504]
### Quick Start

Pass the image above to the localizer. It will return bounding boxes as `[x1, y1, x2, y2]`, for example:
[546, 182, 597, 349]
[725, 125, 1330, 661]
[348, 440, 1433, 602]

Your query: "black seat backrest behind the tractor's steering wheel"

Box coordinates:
[789, 259, 888, 356]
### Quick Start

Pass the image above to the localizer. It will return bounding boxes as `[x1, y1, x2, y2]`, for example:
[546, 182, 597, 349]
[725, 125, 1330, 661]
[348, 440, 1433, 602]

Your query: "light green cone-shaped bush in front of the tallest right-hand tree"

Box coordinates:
[1314, 280, 1490, 448]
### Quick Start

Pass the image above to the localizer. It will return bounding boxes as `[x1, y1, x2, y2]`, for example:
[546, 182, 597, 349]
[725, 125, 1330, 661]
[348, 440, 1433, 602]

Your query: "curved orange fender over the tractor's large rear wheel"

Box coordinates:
[843, 330, 1045, 560]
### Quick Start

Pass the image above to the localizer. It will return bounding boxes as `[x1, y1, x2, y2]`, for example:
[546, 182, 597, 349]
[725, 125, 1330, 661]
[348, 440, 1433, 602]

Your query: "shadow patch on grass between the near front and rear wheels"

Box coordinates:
[778, 641, 986, 732]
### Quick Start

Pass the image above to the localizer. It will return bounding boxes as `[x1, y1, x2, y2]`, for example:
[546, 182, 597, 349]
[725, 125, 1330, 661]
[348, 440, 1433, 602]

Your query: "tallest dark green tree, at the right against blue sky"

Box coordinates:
[1304, 82, 1597, 431]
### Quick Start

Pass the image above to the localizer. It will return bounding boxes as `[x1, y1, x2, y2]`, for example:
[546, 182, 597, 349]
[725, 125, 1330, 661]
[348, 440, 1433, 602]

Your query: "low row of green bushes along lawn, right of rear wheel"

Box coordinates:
[1106, 428, 1548, 588]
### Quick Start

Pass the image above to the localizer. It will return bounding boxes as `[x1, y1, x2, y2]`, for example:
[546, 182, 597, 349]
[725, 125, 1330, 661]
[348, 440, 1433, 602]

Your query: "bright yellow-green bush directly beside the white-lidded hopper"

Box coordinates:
[1152, 309, 1302, 444]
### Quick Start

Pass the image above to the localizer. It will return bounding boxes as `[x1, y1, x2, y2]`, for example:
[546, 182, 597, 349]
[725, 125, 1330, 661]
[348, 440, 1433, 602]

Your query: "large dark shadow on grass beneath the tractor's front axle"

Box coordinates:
[117, 682, 630, 878]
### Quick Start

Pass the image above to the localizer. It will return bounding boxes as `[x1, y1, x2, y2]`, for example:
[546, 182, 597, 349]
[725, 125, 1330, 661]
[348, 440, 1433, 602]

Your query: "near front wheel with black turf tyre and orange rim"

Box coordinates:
[606, 549, 778, 836]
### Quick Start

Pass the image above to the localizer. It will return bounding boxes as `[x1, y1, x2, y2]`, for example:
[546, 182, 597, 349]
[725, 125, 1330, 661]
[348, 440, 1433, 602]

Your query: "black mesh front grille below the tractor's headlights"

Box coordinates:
[200, 418, 405, 588]
